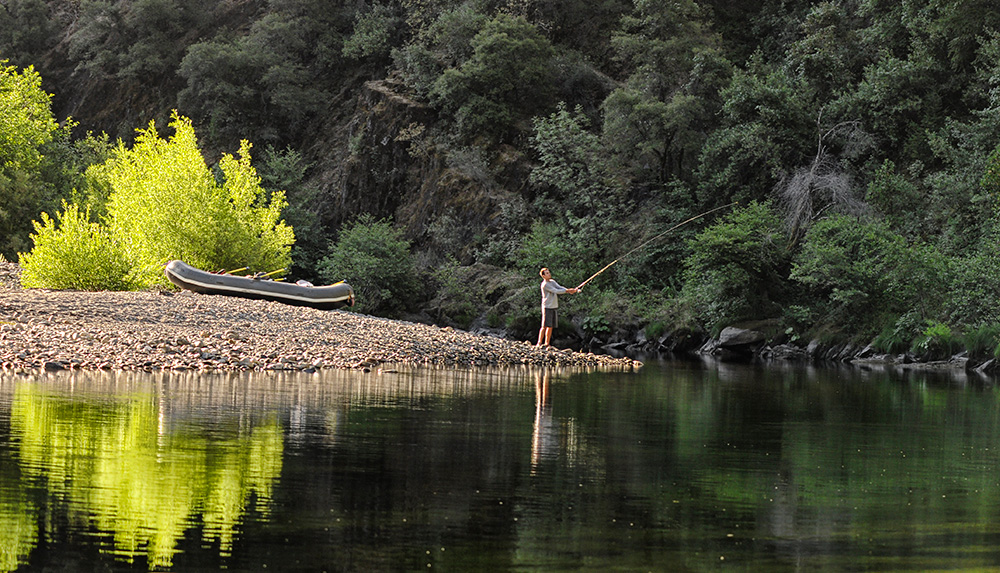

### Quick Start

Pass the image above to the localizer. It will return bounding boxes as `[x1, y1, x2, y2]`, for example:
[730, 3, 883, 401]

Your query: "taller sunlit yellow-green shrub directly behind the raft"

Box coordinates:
[88, 113, 295, 285]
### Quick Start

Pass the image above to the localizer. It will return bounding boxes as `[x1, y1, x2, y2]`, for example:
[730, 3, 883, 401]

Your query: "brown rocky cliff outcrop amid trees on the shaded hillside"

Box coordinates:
[332, 79, 527, 252]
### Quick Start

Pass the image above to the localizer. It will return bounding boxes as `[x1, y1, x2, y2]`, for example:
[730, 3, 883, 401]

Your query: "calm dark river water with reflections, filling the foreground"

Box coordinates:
[0, 362, 1000, 571]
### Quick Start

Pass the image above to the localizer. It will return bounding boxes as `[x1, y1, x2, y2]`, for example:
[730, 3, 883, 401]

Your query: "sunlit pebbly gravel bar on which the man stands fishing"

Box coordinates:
[0, 262, 642, 372]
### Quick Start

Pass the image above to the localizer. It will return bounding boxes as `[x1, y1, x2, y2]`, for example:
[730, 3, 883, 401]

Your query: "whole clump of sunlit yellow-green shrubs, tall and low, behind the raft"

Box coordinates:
[20, 115, 294, 290]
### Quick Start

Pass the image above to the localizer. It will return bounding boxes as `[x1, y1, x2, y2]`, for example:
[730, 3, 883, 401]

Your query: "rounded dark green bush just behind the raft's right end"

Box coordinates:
[319, 213, 419, 316]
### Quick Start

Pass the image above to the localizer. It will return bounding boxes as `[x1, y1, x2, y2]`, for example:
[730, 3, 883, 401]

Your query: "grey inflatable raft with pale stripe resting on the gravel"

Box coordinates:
[164, 261, 354, 310]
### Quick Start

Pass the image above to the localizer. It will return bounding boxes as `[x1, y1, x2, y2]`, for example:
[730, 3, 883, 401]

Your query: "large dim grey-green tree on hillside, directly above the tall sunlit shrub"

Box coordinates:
[177, 0, 352, 147]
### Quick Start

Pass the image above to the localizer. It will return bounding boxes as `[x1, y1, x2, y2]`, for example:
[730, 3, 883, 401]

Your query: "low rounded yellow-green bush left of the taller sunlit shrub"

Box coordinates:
[19, 203, 139, 290]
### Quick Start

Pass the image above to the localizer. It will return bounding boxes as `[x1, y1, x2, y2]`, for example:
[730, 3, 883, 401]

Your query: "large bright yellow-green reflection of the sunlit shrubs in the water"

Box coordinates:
[7, 384, 283, 568]
